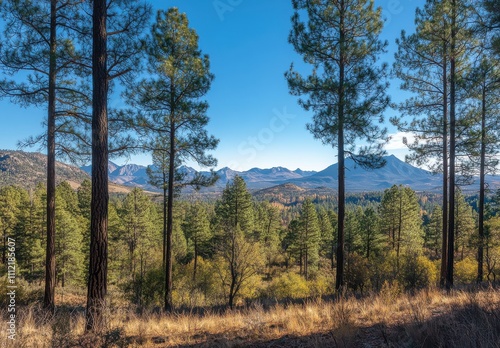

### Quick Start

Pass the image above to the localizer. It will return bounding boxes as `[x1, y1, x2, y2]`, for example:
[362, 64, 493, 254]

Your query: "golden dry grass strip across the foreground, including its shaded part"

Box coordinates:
[0, 288, 500, 348]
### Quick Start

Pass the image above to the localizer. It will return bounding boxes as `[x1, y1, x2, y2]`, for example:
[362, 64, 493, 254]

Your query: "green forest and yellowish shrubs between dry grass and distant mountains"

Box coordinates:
[0, 177, 500, 304]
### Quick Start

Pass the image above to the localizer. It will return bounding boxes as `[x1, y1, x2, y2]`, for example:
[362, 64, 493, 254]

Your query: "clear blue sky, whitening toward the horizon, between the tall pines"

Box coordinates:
[0, 0, 422, 170]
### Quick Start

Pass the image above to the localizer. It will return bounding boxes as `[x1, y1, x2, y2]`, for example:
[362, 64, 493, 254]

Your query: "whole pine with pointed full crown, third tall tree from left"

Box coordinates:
[126, 8, 218, 311]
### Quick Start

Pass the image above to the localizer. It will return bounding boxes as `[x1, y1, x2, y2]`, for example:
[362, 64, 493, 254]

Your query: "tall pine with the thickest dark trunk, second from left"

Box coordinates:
[85, 0, 150, 331]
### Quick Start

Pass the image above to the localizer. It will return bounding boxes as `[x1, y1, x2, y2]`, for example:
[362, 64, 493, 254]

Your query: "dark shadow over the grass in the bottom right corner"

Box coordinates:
[169, 301, 500, 348]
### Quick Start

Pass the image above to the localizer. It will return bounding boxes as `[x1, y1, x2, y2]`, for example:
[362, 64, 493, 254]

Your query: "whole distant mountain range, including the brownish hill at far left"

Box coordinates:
[0, 150, 500, 193]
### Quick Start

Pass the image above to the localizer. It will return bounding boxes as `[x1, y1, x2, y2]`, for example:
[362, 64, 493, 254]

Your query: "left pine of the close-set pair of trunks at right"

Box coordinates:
[391, 1, 450, 286]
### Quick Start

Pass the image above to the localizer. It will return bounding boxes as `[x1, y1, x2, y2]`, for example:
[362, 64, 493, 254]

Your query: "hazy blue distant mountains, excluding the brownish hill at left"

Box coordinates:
[82, 155, 500, 192]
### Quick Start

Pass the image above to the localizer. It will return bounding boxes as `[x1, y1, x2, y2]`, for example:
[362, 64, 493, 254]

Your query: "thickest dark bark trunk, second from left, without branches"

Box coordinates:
[86, 0, 109, 331]
